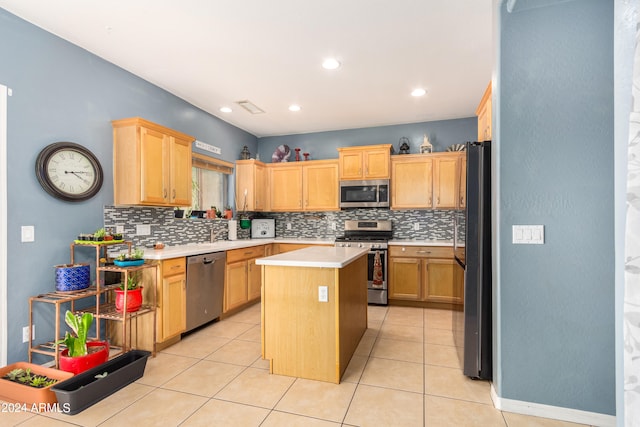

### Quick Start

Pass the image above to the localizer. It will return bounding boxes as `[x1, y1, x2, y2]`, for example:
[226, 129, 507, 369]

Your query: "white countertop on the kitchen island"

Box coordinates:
[256, 246, 369, 268]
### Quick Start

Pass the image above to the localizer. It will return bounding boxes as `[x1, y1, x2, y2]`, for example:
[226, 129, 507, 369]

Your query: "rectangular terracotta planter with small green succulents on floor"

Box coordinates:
[0, 362, 73, 405]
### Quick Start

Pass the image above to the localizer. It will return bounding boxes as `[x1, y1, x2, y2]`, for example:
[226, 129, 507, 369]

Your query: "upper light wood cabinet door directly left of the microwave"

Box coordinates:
[302, 162, 339, 211]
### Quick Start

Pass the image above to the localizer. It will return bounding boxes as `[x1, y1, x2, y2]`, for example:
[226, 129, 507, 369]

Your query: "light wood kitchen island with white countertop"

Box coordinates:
[256, 246, 368, 383]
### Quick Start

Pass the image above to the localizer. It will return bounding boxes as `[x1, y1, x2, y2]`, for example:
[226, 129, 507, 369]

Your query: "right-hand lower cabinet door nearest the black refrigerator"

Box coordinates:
[424, 259, 462, 304]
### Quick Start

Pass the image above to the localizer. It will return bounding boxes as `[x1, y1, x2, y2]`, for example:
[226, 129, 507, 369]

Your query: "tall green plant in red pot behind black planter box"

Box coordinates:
[58, 310, 109, 374]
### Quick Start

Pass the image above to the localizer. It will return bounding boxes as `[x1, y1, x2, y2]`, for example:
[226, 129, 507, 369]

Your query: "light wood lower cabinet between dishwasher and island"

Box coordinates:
[223, 245, 271, 313]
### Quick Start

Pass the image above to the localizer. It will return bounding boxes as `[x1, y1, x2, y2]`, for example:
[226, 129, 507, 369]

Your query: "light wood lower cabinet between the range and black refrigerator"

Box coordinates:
[389, 246, 463, 305]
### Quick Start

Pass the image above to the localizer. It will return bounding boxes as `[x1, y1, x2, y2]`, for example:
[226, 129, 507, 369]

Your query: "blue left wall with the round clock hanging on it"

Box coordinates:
[0, 9, 257, 363]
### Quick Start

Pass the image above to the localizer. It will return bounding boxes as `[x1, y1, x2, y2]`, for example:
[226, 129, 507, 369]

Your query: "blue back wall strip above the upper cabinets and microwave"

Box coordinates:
[252, 117, 482, 163]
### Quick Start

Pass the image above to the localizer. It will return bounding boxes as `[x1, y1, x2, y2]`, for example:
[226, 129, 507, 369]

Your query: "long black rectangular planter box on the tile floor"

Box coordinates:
[52, 350, 151, 415]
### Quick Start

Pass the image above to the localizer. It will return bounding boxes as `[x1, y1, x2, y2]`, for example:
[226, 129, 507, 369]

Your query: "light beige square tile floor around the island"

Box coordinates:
[0, 304, 592, 427]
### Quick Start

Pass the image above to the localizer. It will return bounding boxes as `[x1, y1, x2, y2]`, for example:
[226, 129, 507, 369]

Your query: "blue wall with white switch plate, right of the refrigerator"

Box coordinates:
[495, 0, 616, 414]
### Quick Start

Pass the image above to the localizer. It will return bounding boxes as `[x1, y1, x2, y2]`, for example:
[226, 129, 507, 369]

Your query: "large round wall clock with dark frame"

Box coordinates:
[36, 142, 103, 202]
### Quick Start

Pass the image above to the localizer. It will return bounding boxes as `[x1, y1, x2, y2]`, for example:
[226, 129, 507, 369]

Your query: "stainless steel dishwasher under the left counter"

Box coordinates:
[187, 252, 227, 331]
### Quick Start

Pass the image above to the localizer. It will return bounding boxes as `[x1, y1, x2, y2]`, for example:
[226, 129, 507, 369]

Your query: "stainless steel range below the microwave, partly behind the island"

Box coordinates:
[335, 220, 393, 305]
